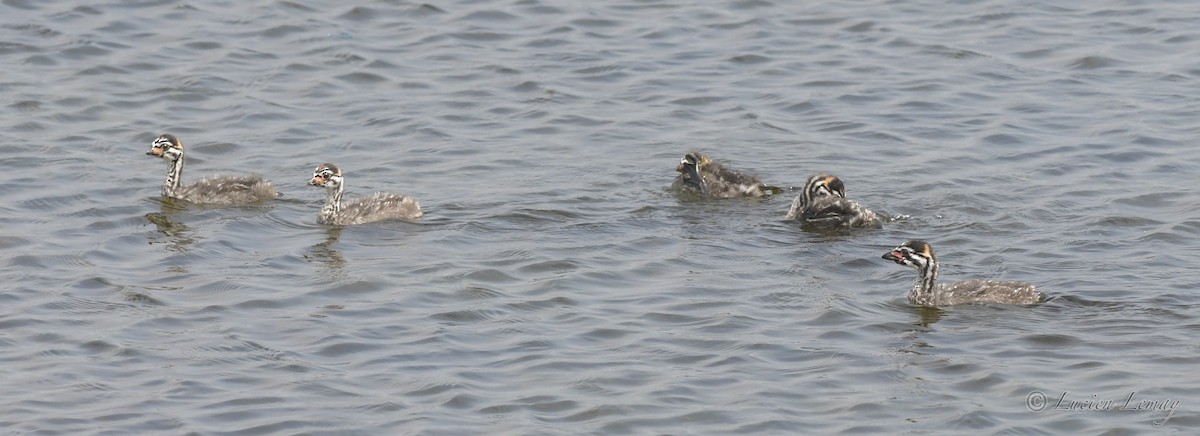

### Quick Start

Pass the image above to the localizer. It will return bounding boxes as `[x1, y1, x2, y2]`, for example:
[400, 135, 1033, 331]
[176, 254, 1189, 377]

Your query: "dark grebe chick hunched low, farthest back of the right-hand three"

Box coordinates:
[672, 151, 784, 198]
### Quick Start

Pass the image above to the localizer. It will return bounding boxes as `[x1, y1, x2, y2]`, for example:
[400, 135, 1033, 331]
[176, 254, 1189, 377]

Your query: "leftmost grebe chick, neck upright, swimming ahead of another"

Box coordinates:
[146, 135, 280, 204]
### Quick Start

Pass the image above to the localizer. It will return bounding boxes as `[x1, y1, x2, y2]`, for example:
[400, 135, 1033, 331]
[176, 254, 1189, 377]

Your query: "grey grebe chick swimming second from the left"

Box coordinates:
[308, 163, 422, 226]
